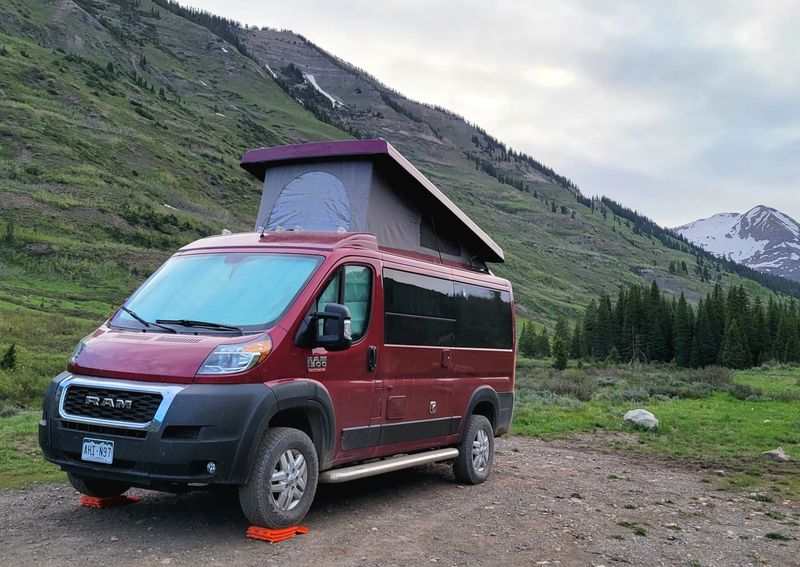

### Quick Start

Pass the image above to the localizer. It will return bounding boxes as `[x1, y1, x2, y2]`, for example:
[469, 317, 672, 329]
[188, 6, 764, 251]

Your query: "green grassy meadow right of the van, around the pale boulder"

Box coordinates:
[512, 366, 800, 498]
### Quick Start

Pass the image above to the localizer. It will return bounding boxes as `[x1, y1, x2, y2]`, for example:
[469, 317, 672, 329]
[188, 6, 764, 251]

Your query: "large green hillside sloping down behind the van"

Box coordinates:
[0, 0, 792, 394]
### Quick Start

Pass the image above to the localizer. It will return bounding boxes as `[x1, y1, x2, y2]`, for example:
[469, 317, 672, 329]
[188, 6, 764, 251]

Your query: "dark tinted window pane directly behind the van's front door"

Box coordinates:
[383, 269, 456, 346]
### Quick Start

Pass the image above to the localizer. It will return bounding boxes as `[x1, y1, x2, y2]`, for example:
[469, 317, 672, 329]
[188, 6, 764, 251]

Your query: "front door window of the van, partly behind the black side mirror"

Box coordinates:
[317, 264, 372, 341]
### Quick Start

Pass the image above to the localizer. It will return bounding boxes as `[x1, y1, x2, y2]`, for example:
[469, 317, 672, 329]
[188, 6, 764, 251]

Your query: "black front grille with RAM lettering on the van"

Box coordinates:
[64, 385, 162, 424]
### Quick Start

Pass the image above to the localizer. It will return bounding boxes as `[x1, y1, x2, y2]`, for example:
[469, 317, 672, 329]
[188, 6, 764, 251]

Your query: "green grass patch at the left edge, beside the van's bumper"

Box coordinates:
[0, 411, 66, 488]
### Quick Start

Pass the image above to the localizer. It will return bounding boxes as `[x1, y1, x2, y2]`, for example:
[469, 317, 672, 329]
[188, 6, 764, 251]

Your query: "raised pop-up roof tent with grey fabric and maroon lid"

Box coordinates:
[241, 140, 504, 270]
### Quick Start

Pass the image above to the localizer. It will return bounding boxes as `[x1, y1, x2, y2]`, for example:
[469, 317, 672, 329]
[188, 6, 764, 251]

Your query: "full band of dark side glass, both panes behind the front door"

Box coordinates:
[383, 269, 512, 349]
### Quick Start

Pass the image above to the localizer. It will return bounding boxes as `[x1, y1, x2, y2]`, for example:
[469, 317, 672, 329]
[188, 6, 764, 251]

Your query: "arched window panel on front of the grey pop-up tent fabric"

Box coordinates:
[267, 171, 351, 231]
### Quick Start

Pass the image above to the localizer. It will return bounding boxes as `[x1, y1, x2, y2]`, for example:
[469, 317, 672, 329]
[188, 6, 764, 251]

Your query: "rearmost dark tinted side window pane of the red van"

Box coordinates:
[455, 282, 513, 349]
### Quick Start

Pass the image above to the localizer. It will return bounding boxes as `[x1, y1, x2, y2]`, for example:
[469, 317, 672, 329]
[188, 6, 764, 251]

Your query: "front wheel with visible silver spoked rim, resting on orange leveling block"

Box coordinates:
[239, 427, 319, 529]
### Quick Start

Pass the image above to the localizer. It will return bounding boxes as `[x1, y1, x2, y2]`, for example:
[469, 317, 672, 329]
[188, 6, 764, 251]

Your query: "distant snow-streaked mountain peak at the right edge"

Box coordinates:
[674, 205, 800, 281]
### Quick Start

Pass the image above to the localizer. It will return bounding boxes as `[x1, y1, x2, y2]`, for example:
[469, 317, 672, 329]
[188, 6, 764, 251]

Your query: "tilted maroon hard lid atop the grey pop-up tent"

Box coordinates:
[240, 139, 505, 262]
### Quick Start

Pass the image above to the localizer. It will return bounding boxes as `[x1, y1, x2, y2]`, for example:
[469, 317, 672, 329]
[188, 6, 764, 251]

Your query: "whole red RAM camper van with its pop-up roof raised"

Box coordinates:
[39, 140, 515, 528]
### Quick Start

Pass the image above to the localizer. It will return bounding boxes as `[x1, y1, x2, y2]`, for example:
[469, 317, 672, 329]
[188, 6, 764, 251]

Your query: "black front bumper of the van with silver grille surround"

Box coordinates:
[39, 372, 277, 490]
